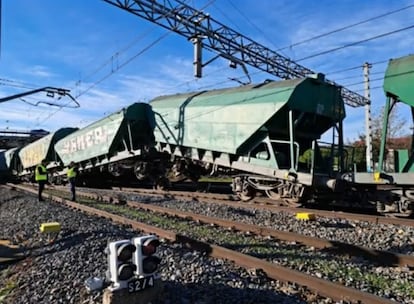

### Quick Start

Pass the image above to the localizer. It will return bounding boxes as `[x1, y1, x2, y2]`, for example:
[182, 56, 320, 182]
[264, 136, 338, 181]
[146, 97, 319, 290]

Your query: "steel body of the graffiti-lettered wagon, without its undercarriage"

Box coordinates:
[55, 103, 155, 166]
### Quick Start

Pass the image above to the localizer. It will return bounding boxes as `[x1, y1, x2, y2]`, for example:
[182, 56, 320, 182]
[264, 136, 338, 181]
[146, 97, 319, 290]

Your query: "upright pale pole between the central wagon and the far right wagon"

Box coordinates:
[363, 62, 373, 172]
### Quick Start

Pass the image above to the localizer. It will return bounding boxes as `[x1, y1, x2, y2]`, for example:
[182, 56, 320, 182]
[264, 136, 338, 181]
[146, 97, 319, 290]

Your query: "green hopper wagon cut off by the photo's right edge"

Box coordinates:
[348, 55, 414, 216]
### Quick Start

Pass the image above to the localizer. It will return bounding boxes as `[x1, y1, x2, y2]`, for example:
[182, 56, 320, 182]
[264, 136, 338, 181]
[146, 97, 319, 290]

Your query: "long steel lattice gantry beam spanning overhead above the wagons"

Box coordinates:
[103, 0, 368, 107]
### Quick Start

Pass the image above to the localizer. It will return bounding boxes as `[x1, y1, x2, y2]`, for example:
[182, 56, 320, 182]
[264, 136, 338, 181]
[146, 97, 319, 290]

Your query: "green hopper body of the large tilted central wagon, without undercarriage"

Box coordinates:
[151, 78, 345, 155]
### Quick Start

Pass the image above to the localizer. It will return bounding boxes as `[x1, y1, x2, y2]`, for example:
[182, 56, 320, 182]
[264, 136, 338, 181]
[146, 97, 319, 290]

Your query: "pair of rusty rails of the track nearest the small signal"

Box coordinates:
[7, 186, 412, 303]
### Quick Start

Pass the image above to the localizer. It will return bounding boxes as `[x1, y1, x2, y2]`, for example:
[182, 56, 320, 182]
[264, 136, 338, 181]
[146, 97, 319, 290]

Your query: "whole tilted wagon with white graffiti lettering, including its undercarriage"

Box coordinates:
[56, 103, 155, 180]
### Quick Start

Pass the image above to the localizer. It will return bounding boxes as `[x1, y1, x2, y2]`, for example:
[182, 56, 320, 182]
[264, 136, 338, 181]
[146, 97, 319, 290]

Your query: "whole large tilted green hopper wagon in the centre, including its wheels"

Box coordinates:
[151, 74, 345, 203]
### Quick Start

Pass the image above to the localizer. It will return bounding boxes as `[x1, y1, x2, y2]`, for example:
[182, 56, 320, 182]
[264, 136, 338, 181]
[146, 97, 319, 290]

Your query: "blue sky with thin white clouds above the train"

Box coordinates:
[0, 0, 414, 140]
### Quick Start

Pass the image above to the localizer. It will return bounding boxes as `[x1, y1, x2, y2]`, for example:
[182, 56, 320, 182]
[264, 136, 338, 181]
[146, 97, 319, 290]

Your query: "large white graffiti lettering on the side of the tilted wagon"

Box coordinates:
[62, 127, 108, 153]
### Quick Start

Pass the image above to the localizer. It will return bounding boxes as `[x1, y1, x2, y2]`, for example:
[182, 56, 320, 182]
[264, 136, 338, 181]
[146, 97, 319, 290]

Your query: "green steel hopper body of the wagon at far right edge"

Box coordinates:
[384, 55, 414, 107]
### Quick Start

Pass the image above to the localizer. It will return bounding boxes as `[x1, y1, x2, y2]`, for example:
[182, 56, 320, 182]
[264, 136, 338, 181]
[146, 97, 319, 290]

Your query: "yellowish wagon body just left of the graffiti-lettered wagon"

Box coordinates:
[19, 128, 77, 169]
